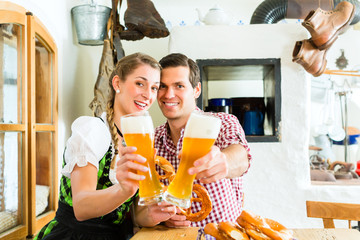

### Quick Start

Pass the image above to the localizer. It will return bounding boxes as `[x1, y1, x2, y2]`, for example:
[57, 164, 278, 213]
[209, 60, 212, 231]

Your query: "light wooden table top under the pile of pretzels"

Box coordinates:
[131, 226, 360, 240]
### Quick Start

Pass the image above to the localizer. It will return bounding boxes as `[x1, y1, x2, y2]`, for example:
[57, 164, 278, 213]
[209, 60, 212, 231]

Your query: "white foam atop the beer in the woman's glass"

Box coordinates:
[120, 116, 154, 134]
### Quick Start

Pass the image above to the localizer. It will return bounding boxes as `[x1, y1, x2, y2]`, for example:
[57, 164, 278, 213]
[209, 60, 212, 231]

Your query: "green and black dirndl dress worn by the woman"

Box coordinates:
[34, 146, 138, 240]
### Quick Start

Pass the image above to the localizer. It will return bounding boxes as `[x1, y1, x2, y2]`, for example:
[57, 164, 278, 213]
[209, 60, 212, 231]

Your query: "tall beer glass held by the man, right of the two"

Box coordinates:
[164, 112, 221, 208]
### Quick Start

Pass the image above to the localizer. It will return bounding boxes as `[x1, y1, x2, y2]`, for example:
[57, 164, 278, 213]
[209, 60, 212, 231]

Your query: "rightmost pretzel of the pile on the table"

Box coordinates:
[236, 210, 294, 240]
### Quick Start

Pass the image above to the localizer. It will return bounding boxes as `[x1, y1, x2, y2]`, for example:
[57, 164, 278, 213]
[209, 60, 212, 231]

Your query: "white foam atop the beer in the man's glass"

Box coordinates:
[184, 113, 221, 139]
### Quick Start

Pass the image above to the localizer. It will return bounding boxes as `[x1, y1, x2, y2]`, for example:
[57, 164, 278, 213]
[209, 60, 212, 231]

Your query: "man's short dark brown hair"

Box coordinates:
[159, 53, 200, 88]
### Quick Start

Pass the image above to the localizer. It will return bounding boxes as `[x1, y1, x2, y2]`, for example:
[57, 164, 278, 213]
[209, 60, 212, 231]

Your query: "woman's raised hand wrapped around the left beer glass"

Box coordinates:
[116, 147, 149, 194]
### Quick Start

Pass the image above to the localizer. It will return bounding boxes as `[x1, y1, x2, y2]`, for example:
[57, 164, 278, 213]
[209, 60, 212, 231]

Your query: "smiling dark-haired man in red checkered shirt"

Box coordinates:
[155, 53, 251, 227]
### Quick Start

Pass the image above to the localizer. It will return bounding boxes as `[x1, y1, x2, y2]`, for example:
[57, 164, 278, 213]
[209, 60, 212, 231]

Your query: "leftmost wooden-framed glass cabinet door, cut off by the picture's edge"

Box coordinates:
[0, 2, 28, 239]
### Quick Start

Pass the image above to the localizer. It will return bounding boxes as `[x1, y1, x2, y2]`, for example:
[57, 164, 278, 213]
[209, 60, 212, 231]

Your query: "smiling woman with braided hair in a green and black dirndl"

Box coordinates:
[35, 53, 176, 240]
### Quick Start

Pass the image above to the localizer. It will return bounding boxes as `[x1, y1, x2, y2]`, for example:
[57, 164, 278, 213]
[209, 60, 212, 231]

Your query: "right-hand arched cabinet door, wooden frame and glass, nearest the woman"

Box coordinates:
[27, 13, 59, 235]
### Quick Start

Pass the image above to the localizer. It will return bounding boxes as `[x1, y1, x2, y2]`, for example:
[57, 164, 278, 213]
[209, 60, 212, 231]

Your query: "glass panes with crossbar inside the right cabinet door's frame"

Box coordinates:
[33, 33, 55, 217]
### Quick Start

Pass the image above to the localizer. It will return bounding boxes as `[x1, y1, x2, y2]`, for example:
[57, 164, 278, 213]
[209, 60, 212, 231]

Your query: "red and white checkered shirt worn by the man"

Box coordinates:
[155, 109, 251, 227]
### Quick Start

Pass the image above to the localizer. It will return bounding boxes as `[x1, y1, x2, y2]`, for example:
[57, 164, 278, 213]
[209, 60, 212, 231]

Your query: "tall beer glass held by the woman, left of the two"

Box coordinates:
[121, 111, 163, 205]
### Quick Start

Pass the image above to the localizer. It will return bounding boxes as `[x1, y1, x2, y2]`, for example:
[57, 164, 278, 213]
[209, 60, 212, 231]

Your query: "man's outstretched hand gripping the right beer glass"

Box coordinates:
[188, 146, 229, 183]
